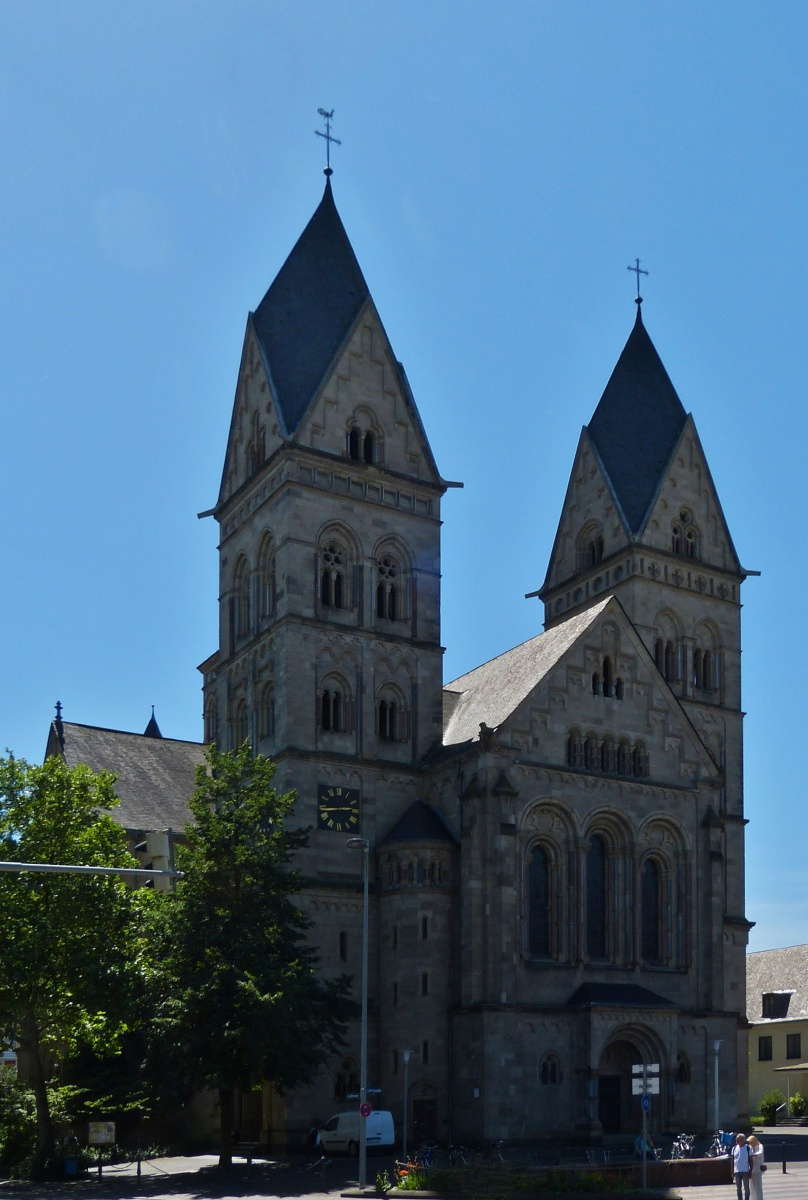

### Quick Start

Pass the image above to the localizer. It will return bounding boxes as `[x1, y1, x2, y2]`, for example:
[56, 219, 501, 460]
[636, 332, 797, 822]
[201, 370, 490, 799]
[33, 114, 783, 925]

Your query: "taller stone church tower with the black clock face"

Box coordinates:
[200, 170, 448, 1136]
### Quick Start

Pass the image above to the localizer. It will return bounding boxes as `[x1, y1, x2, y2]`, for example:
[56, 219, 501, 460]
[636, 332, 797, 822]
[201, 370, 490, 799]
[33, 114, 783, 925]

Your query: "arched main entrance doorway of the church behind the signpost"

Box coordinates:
[598, 1026, 666, 1135]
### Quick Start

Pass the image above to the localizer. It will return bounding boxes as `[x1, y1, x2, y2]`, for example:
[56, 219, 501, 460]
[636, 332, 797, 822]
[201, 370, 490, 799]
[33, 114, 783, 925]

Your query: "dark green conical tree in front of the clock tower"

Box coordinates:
[154, 743, 355, 1166]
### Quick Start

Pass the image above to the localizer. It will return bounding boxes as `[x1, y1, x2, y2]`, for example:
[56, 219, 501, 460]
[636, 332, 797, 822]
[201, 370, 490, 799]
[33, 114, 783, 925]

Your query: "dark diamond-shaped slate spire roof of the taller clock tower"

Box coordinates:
[251, 179, 370, 433]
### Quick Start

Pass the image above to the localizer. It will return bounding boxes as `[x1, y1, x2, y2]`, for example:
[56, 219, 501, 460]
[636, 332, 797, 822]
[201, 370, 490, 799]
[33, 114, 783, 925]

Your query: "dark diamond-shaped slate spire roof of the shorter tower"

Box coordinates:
[587, 305, 687, 533]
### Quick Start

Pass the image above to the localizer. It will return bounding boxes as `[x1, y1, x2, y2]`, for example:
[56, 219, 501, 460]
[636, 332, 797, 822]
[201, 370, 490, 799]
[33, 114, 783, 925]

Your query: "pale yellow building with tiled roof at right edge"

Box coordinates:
[747, 946, 808, 1112]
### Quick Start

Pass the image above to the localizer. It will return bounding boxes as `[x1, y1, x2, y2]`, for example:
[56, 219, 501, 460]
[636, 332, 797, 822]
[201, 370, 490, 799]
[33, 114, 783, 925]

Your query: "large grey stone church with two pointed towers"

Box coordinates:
[52, 172, 749, 1146]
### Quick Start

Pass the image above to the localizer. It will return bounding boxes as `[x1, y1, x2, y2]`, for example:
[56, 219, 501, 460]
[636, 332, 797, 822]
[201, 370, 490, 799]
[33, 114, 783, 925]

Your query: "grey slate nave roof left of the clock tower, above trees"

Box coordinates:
[47, 721, 205, 832]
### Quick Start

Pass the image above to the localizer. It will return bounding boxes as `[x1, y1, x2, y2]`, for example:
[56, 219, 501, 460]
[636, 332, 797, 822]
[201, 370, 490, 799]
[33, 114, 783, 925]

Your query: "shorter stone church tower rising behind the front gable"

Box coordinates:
[538, 299, 752, 1111]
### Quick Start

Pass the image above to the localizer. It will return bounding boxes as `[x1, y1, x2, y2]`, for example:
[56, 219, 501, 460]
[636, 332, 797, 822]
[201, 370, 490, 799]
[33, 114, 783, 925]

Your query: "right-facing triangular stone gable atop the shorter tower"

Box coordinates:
[640, 414, 744, 575]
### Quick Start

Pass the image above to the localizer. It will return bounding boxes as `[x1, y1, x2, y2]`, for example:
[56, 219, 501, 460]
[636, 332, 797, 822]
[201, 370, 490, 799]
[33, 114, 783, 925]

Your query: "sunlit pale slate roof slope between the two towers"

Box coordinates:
[443, 596, 611, 745]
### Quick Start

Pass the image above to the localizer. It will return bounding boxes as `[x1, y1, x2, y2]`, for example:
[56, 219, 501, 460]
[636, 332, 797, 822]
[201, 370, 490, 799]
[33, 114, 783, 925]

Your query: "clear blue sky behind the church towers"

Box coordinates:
[0, 0, 808, 949]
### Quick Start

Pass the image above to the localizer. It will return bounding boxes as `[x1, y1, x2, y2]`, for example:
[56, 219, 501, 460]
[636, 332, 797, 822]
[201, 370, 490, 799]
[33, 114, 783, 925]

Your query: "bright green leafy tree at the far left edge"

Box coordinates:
[0, 756, 148, 1164]
